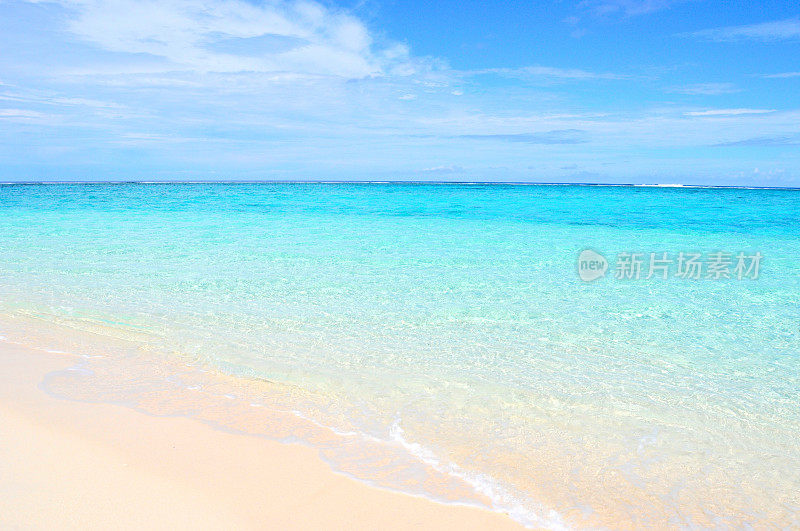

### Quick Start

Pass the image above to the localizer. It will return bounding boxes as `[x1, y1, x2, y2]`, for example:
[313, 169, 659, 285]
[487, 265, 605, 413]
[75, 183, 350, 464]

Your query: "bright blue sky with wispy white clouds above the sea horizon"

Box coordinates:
[0, 0, 800, 186]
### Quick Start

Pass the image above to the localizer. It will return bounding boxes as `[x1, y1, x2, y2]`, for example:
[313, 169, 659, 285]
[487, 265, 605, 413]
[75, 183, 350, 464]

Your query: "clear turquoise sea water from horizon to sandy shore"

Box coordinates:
[0, 184, 800, 527]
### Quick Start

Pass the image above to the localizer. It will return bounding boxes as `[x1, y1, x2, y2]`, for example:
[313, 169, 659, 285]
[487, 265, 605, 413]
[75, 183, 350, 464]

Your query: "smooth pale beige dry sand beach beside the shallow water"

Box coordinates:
[0, 343, 520, 529]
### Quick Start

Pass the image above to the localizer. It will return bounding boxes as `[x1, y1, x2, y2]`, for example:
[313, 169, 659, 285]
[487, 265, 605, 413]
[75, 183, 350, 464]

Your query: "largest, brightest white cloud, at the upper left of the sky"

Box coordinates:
[29, 0, 409, 78]
